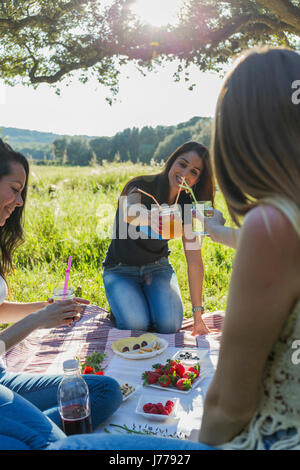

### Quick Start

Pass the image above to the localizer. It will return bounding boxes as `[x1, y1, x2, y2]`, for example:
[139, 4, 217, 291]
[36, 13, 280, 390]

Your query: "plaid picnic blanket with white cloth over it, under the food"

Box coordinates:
[2, 305, 224, 441]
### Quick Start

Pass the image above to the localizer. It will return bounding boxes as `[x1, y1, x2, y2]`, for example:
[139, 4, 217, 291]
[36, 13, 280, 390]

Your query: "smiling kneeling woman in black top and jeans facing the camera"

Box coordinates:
[103, 142, 214, 335]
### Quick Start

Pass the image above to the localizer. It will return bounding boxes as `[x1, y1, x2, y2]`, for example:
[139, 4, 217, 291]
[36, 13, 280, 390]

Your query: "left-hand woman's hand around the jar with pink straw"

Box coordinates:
[32, 297, 89, 328]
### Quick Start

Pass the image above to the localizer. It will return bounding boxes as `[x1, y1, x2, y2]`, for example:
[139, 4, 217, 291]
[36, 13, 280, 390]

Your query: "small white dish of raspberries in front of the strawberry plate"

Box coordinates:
[135, 394, 179, 421]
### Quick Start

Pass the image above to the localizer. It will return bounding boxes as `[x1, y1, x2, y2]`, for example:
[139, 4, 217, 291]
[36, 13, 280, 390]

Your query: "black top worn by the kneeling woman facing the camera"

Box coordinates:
[103, 174, 192, 266]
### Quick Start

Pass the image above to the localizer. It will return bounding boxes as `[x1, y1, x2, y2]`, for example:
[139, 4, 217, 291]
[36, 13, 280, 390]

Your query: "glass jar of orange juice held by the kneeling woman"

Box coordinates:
[159, 205, 182, 240]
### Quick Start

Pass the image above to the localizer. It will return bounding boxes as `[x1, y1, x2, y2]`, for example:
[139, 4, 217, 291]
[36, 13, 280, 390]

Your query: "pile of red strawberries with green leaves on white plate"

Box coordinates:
[142, 359, 202, 393]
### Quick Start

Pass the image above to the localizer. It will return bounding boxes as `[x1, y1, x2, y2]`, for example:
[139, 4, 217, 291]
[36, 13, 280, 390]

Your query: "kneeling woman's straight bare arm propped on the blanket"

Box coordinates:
[182, 236, 209, 336]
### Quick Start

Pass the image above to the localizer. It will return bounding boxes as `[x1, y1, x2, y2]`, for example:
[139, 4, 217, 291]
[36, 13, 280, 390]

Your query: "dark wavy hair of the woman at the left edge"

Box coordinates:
[0, 139, 29, 277]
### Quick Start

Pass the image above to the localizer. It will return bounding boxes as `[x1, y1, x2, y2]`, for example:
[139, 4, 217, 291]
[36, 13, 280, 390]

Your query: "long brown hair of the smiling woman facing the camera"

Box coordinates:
[121, 141, 215, 203]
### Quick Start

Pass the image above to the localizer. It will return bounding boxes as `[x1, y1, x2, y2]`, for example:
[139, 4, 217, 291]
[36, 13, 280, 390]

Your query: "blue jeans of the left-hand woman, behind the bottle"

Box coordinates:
[0, 370, 122, 450]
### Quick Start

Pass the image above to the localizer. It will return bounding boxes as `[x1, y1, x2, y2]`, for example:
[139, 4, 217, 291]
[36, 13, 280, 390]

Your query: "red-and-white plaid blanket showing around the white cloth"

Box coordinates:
[2, 305, 224, 374]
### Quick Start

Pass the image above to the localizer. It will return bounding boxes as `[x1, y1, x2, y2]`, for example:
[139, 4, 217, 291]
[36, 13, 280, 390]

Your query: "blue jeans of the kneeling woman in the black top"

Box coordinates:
[103, 258, 183, 334]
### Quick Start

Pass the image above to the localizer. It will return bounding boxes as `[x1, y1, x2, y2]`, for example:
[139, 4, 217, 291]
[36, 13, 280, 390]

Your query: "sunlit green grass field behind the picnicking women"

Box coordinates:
[0, 163, 234, 326]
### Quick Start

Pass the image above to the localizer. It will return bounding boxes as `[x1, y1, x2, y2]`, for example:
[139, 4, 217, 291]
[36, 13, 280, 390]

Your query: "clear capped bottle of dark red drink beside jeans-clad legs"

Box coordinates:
[57, 359, 92, 436]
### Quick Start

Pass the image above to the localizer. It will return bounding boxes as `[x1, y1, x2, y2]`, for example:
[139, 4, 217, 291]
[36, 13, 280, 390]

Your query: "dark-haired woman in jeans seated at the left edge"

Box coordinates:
[0, 140, 122, 450]
